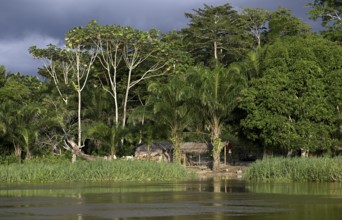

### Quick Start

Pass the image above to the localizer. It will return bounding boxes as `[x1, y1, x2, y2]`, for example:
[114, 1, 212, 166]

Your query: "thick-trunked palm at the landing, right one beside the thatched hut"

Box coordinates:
[188, 66, 245, 170]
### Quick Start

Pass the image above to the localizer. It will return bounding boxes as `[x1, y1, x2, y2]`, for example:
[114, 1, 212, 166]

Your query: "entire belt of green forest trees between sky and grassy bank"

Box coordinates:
[0, 0, 342, 172]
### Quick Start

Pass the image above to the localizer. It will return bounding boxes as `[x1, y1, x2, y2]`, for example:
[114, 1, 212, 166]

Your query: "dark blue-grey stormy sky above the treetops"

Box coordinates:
[0, 0, 317, 75]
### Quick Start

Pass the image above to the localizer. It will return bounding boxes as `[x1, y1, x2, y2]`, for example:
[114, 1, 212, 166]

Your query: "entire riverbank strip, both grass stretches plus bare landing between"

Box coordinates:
[0, 157, 342, 183]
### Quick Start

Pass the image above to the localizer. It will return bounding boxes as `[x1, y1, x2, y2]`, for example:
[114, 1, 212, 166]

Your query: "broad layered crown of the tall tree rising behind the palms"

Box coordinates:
[182, 4, 250, 66]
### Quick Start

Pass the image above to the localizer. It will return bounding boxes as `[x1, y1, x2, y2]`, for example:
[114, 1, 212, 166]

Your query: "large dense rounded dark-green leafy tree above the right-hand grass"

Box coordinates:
[240, 35, 342, 156]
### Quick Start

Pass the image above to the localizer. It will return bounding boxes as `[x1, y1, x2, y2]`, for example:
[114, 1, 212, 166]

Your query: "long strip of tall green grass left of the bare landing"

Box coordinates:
[0, 160, 194, 183]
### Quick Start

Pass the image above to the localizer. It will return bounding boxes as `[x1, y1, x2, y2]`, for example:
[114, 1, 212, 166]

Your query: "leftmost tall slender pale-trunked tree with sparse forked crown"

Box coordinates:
[30, 22, 98, 161]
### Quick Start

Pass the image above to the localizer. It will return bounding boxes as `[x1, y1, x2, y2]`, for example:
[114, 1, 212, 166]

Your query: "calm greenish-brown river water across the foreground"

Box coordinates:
[0, 178, 342, 220]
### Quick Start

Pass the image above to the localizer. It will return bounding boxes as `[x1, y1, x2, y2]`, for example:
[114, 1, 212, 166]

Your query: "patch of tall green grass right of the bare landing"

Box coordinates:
[245, 157, 342, 182]
